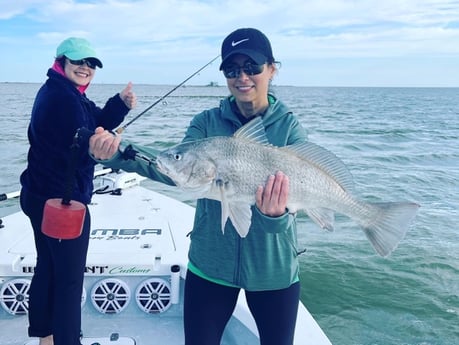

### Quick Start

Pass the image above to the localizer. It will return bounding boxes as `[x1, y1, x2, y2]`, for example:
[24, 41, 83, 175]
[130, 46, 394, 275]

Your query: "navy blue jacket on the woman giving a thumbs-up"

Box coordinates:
[21, 69, 129, 204]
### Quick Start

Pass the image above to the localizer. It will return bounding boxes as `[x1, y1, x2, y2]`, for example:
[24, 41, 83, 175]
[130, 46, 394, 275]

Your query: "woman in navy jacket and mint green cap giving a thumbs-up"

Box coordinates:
[21, 37, 136, 345]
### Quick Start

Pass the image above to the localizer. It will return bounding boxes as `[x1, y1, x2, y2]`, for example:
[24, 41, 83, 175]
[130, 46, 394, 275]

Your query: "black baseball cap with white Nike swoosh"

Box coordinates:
[220, 28, 274, 70]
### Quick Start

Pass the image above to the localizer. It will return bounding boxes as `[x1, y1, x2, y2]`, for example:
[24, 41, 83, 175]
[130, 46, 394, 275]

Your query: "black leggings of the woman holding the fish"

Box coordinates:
[184, 271, 300, 345]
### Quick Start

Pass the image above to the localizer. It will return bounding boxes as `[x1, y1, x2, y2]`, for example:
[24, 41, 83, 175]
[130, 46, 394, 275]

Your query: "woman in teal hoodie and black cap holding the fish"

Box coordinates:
[90, 28, 306, 345]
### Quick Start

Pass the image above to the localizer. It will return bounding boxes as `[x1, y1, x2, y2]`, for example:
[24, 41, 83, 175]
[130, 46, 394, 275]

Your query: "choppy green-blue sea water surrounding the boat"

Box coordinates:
[0, 83, 459, 345]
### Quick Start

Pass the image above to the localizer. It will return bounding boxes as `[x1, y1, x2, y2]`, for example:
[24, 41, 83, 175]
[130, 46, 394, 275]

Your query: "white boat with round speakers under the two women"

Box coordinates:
[0, 169, 331, 345]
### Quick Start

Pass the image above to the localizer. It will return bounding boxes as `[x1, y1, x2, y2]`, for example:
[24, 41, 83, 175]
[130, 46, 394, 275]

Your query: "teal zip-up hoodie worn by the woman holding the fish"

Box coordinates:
[99, 95, 306, 291]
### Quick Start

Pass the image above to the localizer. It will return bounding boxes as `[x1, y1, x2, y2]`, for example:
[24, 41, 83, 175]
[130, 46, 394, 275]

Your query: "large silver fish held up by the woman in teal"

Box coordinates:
[156, 118, 419, 257]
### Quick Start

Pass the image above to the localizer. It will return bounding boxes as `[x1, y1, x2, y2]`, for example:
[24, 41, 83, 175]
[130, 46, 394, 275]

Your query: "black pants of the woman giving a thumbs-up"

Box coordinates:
[21, 190, 91, 345]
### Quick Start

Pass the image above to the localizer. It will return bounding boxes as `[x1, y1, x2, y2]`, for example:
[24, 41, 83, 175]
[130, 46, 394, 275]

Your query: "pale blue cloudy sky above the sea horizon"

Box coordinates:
[0, 0, 459, 87]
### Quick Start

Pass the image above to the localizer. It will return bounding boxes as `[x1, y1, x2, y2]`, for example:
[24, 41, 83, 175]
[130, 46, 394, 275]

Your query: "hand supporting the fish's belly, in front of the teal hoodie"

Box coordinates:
[255, 171, 289, 217]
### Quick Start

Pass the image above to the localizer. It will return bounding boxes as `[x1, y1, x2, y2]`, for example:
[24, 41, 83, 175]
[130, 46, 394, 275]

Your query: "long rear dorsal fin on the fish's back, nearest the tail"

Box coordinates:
[288, 141, 354, 191]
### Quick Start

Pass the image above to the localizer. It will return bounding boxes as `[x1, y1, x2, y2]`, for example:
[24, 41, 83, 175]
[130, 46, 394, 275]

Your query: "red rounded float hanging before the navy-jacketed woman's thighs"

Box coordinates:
[41, 199, 86, 240]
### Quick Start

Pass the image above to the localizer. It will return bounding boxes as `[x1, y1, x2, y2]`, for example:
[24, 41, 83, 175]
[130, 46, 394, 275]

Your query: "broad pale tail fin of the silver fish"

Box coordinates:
[361, 202, 420, 257]
